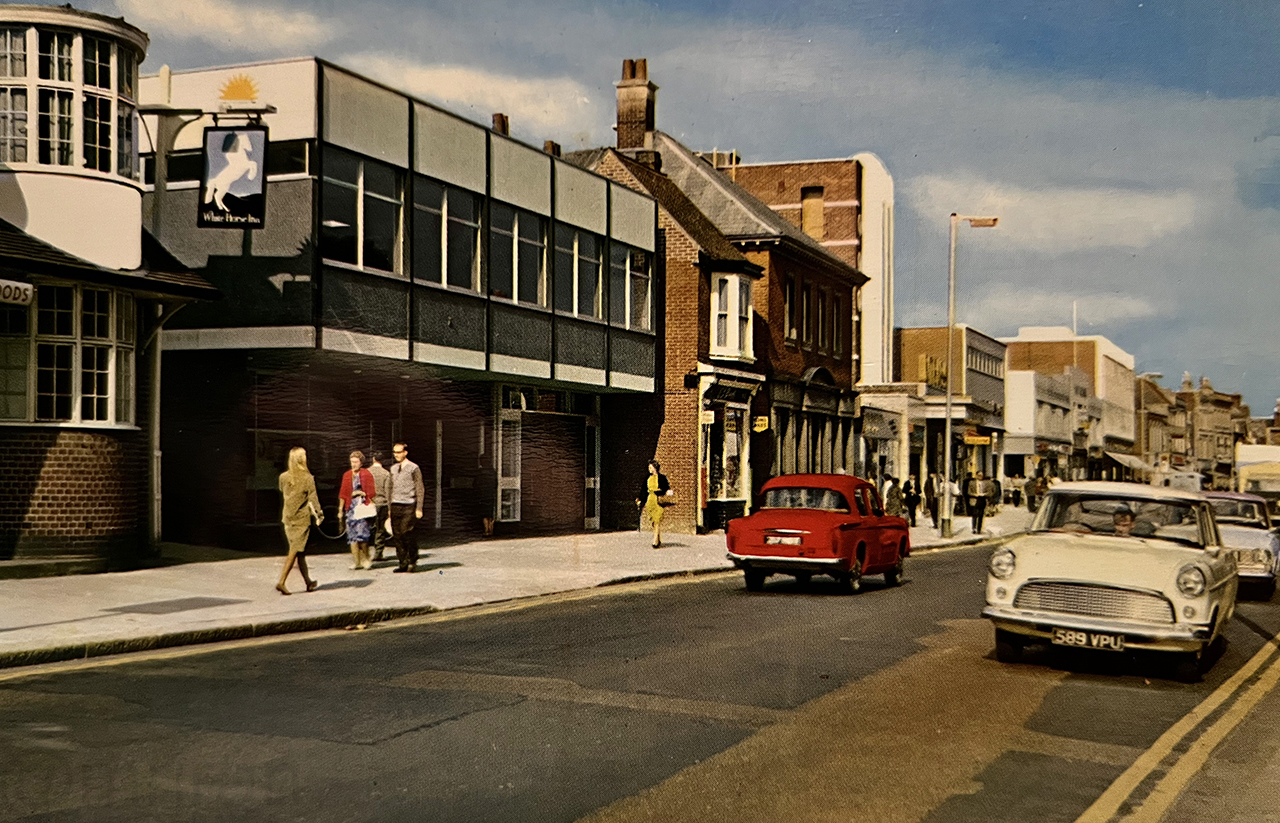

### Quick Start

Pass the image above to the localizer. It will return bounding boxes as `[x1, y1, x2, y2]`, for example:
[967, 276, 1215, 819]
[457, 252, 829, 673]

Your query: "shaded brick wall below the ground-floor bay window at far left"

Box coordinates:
[0, 432, 147, 558]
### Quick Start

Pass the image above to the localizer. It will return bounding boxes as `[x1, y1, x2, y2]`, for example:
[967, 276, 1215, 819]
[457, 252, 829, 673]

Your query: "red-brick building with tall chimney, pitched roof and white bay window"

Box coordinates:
[575, 60, 865, 529]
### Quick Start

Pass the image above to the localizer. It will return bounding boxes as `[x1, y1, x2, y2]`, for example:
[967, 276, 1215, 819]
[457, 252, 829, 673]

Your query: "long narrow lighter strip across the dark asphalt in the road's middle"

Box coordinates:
[389, 671, 792, 728]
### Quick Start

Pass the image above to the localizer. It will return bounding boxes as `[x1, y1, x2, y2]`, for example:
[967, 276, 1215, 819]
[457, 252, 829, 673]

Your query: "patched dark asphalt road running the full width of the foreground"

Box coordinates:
[0, 547, 1280, 823]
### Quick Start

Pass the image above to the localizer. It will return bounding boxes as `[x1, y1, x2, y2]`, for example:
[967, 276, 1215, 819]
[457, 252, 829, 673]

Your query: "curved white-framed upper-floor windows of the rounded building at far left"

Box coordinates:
[0, 28, 138, 179]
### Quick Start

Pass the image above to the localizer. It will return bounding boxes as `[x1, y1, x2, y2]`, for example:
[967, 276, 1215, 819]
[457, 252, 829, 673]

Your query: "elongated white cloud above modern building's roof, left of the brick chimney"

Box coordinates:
[339, 54, 599, 140]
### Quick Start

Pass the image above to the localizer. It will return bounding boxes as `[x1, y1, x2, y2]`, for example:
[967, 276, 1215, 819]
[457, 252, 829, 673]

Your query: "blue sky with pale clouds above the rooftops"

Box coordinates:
[64, 0, 1280, 416]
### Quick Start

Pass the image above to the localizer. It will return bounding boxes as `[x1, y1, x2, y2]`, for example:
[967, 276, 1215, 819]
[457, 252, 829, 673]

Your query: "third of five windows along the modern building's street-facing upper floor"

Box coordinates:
[489, 202, 547, 306]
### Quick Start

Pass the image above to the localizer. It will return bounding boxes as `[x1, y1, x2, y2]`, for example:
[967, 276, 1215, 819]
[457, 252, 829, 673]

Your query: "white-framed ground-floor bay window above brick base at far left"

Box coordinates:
[0, 285, 137, 425]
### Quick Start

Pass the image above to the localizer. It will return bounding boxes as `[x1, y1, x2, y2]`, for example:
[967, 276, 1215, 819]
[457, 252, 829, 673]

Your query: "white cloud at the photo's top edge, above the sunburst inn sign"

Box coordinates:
[115, 0, 337, 55]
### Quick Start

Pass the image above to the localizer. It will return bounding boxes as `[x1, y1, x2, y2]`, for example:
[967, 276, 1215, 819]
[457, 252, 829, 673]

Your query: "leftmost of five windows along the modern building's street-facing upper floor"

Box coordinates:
[320, 146, 402, 273]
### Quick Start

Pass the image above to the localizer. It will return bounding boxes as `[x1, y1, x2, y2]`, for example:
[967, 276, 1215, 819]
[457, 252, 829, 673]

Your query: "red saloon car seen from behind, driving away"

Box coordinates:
[726, 475, 911, 593]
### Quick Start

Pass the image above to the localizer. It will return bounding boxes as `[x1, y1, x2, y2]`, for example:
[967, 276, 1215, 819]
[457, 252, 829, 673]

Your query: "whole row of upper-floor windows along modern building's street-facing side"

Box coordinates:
[320, 146, 653, 332]
